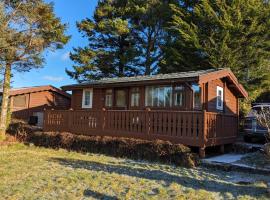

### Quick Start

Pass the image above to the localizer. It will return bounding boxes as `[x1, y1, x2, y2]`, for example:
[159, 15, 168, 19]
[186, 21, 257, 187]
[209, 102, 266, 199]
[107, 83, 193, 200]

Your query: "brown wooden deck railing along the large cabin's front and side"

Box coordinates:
[44, 110, 237, 147]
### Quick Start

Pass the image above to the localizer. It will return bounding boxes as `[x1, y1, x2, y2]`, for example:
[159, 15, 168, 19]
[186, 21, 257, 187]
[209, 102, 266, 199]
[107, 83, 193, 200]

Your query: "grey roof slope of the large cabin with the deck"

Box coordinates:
[63, 69, 222, 88]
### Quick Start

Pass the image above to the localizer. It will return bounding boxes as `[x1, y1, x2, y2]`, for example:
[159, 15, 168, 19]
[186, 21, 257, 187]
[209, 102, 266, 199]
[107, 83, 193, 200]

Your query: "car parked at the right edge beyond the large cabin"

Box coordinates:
[244, 103, 270, 142]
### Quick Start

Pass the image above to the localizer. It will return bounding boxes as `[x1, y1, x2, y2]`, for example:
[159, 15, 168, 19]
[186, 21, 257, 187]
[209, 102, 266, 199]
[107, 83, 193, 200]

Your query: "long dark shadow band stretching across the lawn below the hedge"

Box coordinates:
[51, 158, 266, 198]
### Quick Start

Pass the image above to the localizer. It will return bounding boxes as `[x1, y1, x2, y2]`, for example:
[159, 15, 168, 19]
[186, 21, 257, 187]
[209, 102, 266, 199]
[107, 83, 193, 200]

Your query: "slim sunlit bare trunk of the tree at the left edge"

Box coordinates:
[0, 64, 11, 138]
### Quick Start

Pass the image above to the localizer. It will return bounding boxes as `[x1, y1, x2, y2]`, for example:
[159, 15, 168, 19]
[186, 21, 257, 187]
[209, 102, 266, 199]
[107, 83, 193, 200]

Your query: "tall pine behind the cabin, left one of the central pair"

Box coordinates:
[66, 0, 139, 82]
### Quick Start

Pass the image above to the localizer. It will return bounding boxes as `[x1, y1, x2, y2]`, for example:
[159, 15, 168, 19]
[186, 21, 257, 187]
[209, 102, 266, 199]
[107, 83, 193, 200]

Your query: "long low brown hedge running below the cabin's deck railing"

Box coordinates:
[9, 122, 198, 167]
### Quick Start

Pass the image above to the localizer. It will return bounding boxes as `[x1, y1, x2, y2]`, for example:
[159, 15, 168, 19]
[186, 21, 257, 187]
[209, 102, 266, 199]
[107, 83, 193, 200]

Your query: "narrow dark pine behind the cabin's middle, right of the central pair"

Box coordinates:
[128, 0, 178, 75]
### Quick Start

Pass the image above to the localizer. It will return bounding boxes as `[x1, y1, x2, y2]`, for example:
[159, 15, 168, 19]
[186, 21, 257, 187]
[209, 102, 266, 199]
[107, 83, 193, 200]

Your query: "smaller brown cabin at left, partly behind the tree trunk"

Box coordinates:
[0, 85, 71, 126]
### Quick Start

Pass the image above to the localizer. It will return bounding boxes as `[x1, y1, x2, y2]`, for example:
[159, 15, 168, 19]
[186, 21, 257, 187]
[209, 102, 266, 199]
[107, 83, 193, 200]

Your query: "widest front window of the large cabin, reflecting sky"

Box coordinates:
[145, 86, 172, 107]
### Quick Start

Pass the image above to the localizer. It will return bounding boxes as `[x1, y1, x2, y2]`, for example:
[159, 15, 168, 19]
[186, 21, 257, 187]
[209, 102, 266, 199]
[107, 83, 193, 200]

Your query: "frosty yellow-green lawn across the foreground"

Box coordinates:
[0, 144, 270, 199]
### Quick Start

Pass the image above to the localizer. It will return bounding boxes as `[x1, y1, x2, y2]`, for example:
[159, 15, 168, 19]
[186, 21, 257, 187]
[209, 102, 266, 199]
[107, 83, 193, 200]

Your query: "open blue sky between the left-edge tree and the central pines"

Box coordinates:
[12, 0, 98, 88]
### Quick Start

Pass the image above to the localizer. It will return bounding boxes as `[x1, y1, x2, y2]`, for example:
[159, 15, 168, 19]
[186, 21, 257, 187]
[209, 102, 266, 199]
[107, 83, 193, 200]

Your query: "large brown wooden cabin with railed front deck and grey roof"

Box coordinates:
[45, 69, 248, 154]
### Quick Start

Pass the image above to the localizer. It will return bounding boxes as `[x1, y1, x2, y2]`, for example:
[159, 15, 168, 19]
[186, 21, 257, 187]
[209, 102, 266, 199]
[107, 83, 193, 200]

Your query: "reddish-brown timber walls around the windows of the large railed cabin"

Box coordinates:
[71, 79, 238, 114]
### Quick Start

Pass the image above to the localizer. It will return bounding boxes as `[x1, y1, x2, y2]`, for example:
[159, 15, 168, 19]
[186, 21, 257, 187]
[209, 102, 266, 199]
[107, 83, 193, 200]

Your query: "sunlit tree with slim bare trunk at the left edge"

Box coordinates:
[0, 0, 69, 137]
